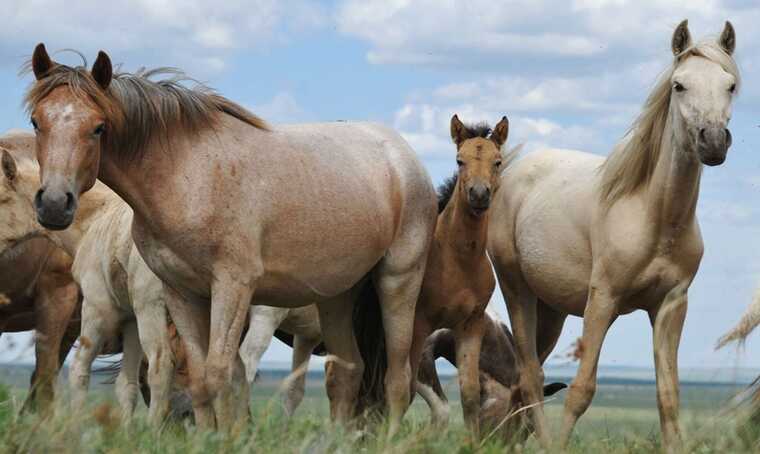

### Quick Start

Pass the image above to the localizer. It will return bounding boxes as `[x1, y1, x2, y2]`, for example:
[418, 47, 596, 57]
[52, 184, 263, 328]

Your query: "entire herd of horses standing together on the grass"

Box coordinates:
[0, 17, 760, 450]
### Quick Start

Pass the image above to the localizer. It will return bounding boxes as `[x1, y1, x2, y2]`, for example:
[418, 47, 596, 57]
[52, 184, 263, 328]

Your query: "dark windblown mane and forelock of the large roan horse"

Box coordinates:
[22, 62, 269, 159]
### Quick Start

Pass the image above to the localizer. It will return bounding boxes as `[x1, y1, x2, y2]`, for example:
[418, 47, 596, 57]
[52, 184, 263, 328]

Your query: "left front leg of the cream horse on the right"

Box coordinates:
[560, 284, 618, 449]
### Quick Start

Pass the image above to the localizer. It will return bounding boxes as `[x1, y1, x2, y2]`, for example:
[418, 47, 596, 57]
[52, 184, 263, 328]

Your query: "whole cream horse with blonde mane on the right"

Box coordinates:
[488, 21, 739, 450]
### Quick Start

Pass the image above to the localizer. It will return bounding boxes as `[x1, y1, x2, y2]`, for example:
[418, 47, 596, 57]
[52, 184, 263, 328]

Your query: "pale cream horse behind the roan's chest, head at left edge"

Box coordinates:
[0, 140, 247, 424]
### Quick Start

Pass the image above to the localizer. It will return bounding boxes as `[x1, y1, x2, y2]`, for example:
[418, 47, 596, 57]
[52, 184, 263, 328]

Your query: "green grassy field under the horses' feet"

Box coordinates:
[0, 371, 760, 453]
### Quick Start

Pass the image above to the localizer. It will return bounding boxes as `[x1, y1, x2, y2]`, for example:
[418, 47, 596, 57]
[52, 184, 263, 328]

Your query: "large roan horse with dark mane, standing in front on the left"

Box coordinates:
[26, 45, 435, 434]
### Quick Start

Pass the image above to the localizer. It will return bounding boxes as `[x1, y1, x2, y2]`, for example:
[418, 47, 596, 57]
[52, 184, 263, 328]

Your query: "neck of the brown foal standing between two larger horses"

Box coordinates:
[435, 184, 488, 261]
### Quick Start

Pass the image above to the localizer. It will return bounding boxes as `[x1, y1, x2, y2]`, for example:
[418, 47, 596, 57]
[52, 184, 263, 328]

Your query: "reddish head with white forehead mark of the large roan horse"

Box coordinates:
[27, 44, 120, 230]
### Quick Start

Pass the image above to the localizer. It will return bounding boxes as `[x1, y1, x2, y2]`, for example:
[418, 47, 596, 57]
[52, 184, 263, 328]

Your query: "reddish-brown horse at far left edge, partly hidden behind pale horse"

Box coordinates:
[0, 129, 80, 411]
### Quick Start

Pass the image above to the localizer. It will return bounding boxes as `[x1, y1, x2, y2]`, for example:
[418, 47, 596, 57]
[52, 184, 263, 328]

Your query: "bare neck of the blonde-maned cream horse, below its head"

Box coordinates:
[648, 116, 702, 228]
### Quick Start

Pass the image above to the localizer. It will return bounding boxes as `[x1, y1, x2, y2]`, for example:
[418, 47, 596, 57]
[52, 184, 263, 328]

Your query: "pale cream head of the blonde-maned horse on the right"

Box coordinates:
[668, 21, 739, 166]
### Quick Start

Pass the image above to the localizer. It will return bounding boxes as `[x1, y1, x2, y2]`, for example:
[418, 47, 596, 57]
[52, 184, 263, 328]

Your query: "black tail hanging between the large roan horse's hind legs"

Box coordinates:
[353, 279, 388, 415]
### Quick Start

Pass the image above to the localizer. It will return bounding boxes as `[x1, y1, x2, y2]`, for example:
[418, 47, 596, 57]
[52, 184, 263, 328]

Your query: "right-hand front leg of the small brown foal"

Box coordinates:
[455, 313, 485, 439]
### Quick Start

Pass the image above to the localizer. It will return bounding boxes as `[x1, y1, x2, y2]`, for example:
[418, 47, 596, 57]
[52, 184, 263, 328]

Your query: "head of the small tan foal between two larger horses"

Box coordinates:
[451, 115, 509, 216]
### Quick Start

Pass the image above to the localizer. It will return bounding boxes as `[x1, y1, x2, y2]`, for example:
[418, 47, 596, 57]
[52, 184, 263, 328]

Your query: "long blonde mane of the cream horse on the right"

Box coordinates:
[600, 41, 740, 208]
